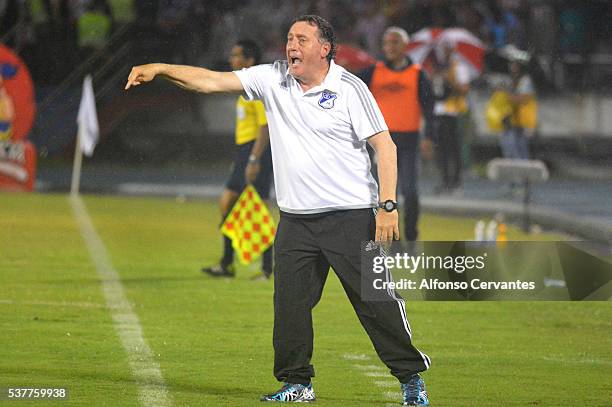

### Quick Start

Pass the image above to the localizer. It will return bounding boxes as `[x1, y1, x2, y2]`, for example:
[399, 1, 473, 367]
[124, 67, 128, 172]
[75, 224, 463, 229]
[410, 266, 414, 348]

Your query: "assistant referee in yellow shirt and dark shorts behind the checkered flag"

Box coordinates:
[202, 40, 272, 278]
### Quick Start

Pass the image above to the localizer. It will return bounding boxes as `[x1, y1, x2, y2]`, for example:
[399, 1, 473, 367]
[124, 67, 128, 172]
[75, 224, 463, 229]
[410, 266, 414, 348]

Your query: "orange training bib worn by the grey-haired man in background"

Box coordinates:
[370, 62, 421, 132]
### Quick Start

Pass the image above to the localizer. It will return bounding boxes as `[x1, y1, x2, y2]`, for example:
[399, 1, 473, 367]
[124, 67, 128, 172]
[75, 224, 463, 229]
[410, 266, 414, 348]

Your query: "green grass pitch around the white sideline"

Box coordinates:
[0, 194, 612, 406]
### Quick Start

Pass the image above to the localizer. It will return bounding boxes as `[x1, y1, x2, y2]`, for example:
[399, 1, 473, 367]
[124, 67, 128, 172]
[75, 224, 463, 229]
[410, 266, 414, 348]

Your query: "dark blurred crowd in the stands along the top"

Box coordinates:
[0, 0, 612, 89]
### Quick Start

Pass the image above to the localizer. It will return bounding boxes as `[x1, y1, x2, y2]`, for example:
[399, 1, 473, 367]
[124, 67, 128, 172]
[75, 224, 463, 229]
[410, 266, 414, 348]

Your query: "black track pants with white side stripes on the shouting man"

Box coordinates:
[273, 209, 430, 384]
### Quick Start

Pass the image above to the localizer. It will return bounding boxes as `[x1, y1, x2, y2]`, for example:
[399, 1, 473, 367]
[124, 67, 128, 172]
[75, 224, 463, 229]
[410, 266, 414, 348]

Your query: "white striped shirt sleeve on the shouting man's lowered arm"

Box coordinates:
[346, 75, 389, 140]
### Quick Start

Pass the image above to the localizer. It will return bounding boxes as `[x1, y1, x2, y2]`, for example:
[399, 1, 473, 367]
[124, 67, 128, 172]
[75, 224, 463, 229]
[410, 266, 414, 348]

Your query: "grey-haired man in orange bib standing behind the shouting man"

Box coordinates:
[359, 27, 434, 241]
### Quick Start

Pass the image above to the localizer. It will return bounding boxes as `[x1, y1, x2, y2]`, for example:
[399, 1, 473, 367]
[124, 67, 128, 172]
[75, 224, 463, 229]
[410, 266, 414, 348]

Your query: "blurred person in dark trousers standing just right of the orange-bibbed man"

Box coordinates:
[432, 42, 470, 193]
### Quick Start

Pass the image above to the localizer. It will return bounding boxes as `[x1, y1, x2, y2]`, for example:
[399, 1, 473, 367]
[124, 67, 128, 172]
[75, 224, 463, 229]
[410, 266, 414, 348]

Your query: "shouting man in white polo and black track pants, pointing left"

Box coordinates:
[126, 15, 430, 406]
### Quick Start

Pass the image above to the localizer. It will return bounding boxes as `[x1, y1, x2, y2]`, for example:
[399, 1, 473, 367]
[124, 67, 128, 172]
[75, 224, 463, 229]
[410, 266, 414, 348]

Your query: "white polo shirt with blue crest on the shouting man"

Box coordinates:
[235, 61, 388, 214]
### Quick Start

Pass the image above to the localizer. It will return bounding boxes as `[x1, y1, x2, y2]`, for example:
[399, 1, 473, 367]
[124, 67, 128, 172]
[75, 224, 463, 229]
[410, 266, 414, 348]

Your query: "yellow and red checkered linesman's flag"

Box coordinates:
[221, 185, 276, 264]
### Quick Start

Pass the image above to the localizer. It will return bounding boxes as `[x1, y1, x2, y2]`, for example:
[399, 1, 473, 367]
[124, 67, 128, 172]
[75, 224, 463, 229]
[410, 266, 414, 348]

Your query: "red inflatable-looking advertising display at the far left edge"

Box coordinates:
[0, 45, 36, 191]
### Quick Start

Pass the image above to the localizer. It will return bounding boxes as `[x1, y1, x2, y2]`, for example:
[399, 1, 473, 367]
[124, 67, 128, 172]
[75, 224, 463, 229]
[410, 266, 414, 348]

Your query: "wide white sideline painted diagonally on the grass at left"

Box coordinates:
[69, 195, 172, 407]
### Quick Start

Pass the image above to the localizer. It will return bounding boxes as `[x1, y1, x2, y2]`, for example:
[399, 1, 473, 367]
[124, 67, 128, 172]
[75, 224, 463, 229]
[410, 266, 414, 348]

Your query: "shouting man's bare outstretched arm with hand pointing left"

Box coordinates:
[125, 64, 243, 93]
